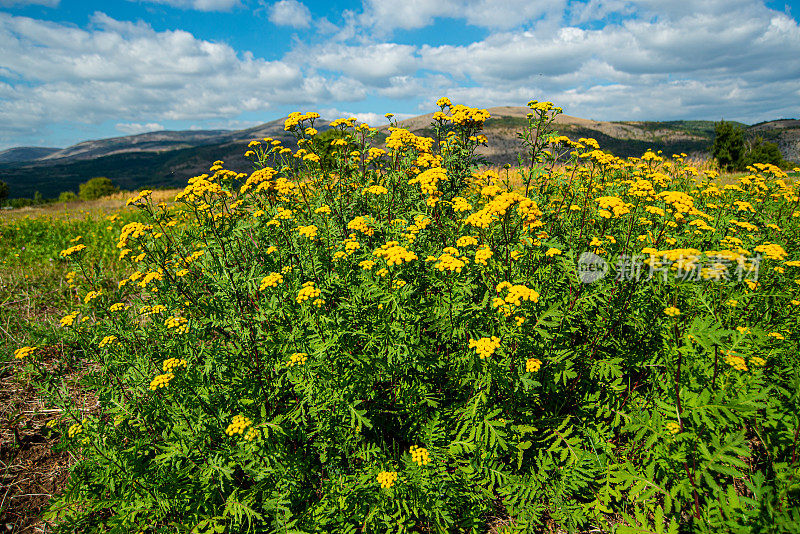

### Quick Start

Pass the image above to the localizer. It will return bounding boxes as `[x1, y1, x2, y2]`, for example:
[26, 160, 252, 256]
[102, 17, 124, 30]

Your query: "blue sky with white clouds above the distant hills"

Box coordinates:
[0, 0, 800, 149]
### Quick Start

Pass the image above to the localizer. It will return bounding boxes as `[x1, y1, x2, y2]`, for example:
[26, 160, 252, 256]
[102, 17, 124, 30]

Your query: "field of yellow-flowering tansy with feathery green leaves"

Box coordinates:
[0, 98, 800, 534]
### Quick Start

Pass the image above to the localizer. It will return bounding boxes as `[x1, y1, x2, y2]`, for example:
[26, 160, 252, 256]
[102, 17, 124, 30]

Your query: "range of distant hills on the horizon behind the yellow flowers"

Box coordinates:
[0, 106, 800, 198]
